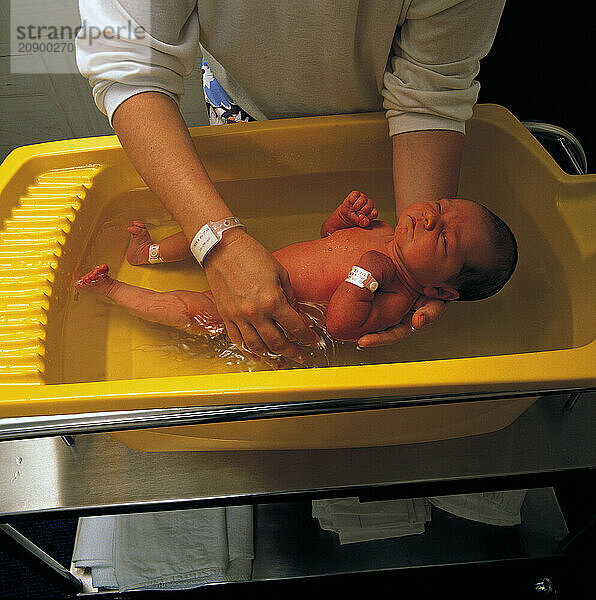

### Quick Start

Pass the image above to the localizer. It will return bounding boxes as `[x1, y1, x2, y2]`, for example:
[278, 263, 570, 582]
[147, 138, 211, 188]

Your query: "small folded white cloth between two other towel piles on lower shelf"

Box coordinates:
[312, 498, 430, 544]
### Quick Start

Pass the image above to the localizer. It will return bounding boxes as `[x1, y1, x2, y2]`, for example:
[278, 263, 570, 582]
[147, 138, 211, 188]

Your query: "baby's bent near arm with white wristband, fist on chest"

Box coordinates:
[326, 250, 413, 341]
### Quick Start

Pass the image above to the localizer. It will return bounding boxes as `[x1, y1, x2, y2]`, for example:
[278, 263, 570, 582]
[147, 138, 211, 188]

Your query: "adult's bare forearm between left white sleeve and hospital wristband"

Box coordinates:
[112, 92, 231, 239]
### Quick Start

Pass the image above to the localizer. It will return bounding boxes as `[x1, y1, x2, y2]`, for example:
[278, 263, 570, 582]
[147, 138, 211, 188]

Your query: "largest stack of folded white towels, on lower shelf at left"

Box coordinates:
[73, 506, 254, 591]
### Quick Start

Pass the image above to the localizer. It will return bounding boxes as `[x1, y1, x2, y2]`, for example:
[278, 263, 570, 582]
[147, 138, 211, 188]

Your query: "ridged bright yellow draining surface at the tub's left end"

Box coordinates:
[0, 166, 101, 384]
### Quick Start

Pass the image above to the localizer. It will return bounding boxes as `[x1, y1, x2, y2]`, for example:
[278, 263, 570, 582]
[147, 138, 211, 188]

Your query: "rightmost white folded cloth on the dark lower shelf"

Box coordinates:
[428, 490, 527, 526]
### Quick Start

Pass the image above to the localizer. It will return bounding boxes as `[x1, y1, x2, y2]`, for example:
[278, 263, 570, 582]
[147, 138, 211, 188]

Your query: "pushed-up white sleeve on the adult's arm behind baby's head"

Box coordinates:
[382, 0, 505, 135]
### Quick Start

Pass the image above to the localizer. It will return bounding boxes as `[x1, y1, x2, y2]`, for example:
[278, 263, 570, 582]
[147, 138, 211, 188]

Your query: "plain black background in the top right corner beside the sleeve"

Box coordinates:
[477, 0, 596, 173]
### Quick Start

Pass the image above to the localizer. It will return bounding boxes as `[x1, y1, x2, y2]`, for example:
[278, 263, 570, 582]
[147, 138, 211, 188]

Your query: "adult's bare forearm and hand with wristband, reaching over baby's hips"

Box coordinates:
[112, 92, 318, 362]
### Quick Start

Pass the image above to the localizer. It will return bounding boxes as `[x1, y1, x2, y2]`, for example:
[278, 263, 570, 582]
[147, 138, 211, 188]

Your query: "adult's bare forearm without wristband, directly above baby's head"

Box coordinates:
[393, 130, 464, 217]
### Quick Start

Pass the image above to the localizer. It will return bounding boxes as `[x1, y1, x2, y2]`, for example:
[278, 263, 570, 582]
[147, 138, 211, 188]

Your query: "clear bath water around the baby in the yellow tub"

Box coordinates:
[59, 171, 569, 383]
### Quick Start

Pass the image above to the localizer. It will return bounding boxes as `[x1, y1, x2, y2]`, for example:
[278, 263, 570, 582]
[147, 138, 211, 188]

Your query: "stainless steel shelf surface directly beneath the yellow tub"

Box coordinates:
[0, 393, 596, 515]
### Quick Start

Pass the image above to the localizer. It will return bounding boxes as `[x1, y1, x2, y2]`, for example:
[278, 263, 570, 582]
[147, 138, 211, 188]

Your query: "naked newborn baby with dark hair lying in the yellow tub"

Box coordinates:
[76, 191, 517, 360]
